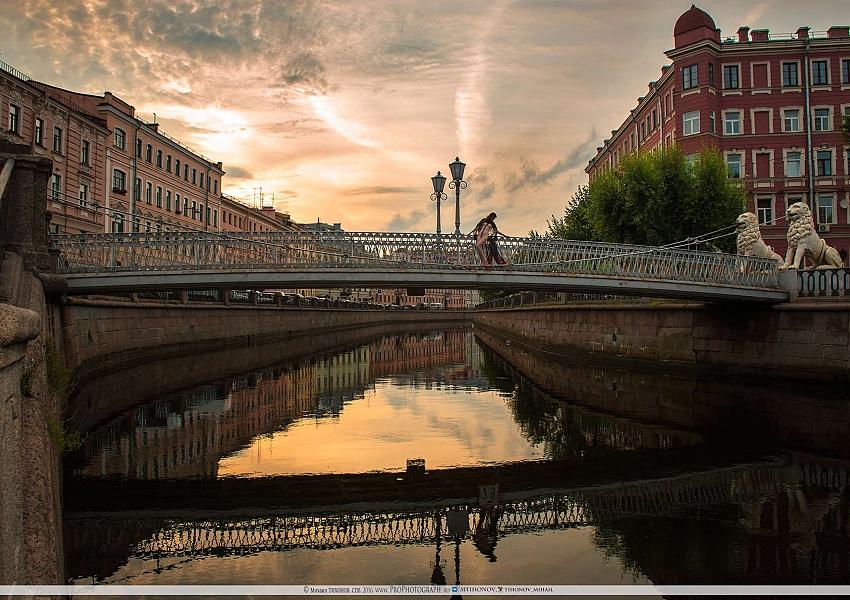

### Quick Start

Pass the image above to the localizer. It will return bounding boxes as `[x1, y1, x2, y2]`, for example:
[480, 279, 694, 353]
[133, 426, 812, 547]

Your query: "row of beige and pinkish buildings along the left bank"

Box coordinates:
[0, 56, 297, 233]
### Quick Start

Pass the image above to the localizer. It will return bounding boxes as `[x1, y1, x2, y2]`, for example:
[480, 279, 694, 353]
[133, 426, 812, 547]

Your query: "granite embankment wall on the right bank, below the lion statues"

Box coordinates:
[474, 302, 850, 382]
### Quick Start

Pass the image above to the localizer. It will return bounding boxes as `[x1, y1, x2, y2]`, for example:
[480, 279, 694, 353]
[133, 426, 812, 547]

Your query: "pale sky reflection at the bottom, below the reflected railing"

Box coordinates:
[93, 527, 650, 585]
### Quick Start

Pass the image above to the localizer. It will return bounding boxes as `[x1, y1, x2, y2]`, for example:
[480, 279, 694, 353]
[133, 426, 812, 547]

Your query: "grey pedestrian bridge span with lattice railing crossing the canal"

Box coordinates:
[53, 232, 787, 302]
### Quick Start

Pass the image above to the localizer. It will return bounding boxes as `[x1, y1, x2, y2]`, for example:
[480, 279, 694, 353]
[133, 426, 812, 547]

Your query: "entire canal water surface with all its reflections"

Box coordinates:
[64, 326, 850, 585]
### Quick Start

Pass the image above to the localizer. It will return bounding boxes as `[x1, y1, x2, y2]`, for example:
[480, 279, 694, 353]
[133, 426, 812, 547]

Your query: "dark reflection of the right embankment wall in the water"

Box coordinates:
[475, 327, 850, 458]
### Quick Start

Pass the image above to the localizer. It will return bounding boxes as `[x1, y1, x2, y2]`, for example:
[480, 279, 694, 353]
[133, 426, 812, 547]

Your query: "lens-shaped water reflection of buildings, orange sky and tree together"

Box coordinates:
[74, 328, 700, 480]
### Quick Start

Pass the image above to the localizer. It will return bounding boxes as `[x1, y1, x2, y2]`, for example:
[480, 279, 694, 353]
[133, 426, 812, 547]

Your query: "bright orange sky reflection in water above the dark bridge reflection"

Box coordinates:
[219, 381, 543, 476]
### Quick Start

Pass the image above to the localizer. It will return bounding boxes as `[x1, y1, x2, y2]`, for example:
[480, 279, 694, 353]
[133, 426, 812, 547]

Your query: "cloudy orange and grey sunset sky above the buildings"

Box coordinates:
[0, 0, 850, 235]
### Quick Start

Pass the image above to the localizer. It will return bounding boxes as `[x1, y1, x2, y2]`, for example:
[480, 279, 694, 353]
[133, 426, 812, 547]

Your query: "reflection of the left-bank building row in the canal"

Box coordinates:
[76, 329, 470, 479]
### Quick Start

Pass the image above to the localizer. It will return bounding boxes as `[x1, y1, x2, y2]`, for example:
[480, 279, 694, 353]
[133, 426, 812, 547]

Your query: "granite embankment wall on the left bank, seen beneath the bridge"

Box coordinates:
[51, 298, 472, 383]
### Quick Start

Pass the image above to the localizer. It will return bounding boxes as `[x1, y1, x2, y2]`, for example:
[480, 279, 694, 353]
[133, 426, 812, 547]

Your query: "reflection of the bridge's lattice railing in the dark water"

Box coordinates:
[66, 463, 788, 558]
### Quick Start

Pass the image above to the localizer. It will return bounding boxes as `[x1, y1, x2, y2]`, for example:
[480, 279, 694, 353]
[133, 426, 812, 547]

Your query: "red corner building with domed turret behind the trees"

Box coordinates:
[585, 6, 850, 261]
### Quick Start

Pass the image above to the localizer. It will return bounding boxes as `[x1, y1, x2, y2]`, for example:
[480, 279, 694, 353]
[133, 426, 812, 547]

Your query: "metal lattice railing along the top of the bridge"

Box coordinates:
[53, 232, 779, 289]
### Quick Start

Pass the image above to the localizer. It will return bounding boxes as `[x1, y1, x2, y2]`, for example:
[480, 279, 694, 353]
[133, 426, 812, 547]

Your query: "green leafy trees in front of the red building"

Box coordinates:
[547, 147, 746, 251]
